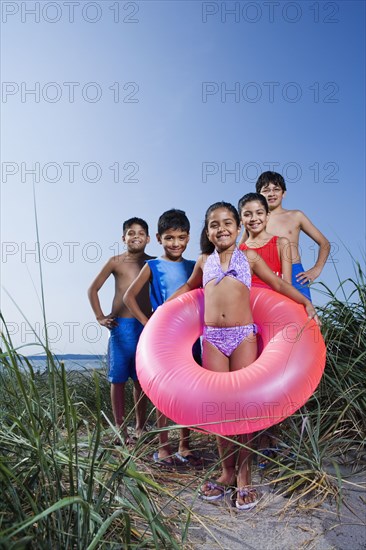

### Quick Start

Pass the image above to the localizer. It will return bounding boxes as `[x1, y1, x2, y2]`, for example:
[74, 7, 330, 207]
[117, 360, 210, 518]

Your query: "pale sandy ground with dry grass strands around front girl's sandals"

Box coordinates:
[138, 438, 366, 550]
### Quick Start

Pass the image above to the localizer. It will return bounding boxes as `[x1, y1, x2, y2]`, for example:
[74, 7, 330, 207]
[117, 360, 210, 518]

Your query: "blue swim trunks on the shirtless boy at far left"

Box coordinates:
[108, 317, 144, 384]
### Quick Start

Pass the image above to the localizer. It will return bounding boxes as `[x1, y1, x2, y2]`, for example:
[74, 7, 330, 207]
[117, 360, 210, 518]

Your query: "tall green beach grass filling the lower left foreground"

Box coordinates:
[0, 335, 189, 549]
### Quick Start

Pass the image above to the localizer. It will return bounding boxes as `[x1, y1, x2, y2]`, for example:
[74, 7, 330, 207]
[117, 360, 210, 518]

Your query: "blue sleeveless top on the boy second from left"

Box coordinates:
[146, 258, 196, 311]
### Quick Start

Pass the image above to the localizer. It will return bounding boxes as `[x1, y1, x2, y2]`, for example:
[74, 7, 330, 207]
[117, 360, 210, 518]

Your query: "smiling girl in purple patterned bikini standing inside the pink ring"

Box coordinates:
[169, 202, 319, 510]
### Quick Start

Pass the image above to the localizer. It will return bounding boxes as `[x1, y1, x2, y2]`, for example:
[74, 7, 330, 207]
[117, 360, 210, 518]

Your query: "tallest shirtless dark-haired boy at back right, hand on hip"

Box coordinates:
[256, 172, 330, 300]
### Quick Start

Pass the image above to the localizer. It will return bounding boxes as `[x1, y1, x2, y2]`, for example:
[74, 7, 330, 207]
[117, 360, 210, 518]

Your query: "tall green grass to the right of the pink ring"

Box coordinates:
[258, 261, 366, 502]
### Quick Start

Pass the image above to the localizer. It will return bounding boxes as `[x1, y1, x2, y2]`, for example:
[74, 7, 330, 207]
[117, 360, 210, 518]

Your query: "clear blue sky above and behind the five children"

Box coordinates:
[1, 0, 365, 353]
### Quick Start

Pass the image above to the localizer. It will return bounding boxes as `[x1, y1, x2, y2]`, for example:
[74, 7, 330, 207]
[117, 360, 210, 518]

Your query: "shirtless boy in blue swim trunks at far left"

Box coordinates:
[88, 218, 152, 444]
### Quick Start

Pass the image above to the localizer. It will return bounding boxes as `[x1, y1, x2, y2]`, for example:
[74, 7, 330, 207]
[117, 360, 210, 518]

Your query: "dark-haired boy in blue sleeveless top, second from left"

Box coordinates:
[123, 209, 201, 466]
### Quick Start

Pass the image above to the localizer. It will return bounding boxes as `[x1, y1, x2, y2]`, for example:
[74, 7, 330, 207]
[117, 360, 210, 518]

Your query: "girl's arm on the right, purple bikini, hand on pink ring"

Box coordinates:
[244, 250, 320, 325]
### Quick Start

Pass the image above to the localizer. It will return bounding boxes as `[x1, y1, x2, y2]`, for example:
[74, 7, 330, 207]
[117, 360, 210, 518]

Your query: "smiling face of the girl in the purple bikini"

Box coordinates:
[207, 208, 240, 251]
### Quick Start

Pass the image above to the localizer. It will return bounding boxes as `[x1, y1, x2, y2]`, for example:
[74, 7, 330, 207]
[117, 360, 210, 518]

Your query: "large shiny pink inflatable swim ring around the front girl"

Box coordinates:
[136, 288, 325, 435]
